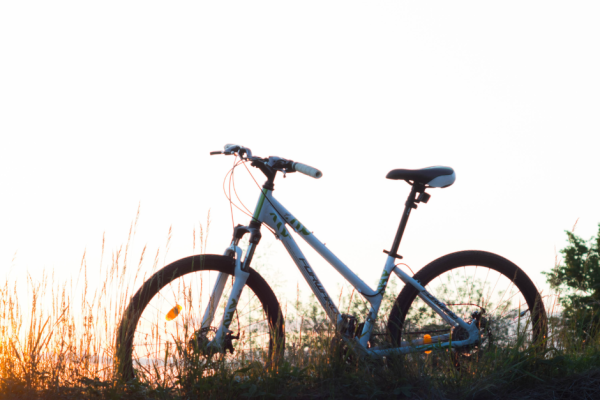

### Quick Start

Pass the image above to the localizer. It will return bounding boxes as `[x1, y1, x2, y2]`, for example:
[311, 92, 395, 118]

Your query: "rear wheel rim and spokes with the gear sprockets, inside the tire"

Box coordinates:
[398, 265, 544, 358]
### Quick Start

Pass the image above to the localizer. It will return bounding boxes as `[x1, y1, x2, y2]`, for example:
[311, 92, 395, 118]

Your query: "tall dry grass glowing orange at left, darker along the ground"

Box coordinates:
[0, 222, 600, 399]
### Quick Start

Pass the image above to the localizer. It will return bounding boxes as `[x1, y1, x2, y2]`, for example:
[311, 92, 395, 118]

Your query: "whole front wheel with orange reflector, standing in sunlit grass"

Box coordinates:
[116, 255, 285, 384]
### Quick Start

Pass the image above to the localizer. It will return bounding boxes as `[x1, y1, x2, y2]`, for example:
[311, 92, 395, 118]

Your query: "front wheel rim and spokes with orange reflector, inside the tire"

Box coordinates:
[131, 270, 272, 384]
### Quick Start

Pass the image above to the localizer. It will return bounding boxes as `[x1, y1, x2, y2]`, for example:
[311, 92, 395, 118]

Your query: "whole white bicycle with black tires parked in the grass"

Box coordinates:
[116, 145, 547, 380]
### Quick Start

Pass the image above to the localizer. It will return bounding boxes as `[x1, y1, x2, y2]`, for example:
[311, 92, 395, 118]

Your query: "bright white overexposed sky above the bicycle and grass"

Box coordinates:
[0, 0, 600, 304]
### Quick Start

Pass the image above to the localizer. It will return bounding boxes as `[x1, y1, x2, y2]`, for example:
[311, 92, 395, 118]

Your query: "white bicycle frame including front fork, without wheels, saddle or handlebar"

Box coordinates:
[202, 189, 479, 357]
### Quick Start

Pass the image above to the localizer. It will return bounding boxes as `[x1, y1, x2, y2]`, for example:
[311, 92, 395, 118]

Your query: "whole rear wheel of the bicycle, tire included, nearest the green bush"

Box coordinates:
[388, 251, 547, 358]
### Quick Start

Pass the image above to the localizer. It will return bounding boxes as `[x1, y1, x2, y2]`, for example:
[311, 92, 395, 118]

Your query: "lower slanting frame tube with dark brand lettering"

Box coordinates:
[264, 211, 341, 326]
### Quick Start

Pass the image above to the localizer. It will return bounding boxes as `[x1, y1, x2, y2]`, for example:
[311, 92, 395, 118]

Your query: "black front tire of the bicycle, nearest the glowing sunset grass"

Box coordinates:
[116, 255, 285, 381]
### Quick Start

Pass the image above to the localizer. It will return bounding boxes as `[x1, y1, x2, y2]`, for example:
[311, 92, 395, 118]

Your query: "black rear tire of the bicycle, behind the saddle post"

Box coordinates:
[387, 250, 547, 353]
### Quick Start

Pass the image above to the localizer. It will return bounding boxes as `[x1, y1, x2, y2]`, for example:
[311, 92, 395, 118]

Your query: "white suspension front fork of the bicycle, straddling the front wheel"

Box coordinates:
[202, 225, 260, 352]
